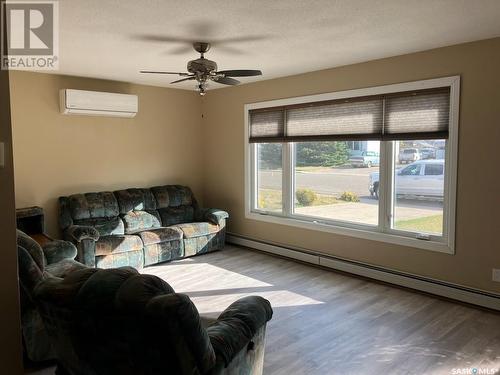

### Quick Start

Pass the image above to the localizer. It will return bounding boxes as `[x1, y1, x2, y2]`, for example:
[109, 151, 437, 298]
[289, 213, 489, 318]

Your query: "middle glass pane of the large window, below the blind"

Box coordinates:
[292, 141, 379, 225]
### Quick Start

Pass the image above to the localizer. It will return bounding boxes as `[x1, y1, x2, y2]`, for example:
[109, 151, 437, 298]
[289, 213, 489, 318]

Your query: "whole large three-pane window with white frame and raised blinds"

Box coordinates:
[245, 77, 459, 253]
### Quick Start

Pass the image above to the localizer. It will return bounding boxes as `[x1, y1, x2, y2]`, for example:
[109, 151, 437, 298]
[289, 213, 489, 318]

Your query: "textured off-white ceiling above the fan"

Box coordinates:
[49, 0, 500, 89]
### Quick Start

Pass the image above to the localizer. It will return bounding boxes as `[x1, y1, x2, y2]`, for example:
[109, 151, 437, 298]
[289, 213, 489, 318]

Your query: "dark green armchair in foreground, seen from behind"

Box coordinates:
[35, 267, 273, 375]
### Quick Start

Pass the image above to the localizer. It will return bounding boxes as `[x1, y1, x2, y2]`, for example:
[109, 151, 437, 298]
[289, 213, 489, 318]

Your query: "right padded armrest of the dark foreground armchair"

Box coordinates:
[207, 296, 273, 366]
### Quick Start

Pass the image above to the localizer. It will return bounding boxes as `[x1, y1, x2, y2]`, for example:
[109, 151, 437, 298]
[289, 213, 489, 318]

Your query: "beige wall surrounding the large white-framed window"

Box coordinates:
[203, 38, 500, 292]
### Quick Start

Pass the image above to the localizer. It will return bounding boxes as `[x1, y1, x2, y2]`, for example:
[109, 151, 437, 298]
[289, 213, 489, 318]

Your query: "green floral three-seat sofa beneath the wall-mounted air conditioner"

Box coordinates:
[59, 185, 229, 268]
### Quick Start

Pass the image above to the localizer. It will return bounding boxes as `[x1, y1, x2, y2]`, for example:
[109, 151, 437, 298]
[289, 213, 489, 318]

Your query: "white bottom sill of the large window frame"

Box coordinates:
[245, 212, 455, 254]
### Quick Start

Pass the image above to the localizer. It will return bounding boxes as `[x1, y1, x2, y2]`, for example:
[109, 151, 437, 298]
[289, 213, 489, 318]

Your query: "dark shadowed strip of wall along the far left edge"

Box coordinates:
[0, 70, 22, 374]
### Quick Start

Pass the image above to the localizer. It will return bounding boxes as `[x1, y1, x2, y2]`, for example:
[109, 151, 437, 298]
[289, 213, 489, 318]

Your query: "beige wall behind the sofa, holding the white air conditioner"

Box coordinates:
[10, 72, 202, 236]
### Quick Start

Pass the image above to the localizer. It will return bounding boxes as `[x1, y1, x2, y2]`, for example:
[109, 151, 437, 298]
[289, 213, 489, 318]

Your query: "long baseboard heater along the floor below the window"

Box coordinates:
[227, 233, 500, 311]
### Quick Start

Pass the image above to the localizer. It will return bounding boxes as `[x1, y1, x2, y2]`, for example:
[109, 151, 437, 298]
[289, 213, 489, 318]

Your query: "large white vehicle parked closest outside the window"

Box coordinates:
[368, 160, 444, 199]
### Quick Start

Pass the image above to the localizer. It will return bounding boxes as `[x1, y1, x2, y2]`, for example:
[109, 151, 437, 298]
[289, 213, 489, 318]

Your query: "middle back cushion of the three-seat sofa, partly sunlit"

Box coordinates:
[114, 188, 161, 234]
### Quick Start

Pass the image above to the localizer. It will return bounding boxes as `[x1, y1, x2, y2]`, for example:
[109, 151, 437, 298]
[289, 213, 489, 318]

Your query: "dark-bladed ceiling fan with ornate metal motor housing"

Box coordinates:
[140, 42, 262, 95]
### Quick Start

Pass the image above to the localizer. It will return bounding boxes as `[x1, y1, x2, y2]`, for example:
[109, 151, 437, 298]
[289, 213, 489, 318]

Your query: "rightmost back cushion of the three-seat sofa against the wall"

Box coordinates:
[151, 185, 196, 226]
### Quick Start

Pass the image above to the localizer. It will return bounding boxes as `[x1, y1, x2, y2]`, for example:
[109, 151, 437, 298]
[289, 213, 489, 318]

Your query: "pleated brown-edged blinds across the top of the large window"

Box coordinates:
[249, 88, 450, 143]
